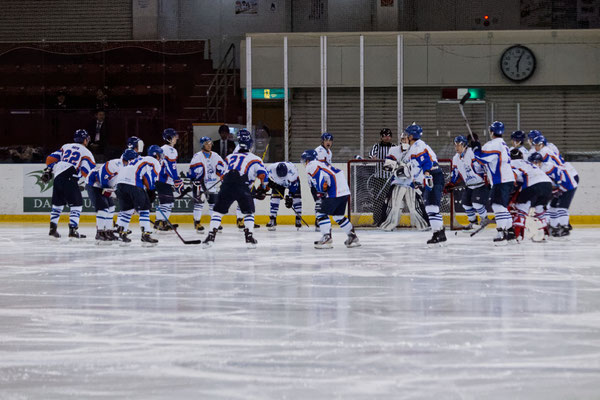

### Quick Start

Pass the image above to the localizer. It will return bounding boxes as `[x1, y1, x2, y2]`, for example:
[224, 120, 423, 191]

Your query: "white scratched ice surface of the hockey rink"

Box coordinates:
[0, 224, 600, 400]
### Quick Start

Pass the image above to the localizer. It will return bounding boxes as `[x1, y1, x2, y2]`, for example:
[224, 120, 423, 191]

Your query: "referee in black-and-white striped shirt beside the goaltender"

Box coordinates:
[369, 128, 395, 226]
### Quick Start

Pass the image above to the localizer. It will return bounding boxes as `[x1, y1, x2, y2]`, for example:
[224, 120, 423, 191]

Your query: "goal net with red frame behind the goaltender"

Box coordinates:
[348, 160, 464, 230]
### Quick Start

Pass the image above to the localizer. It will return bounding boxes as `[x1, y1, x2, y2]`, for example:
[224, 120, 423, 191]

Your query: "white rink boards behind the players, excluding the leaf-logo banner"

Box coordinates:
[0, 162, 600, 216]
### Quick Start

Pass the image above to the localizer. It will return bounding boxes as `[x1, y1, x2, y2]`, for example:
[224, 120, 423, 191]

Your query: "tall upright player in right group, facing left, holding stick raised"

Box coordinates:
[471, 121, 515, 246]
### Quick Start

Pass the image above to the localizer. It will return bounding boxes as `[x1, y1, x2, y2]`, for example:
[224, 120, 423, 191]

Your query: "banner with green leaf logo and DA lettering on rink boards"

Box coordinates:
[23, 164, 194, 213]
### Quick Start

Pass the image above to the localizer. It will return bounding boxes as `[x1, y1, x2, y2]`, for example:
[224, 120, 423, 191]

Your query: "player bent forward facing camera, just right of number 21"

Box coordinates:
[267, 161, 302, 231]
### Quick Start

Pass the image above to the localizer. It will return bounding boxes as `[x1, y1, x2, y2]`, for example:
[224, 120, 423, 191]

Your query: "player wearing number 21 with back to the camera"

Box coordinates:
[203, 135, 268, 248]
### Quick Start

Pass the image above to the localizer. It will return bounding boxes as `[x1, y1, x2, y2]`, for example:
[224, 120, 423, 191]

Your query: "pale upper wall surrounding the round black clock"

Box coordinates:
[241, 30, 600, 87]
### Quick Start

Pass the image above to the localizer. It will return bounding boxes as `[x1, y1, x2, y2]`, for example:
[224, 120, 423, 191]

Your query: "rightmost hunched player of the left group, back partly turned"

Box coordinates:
[116, 145, 163, 246]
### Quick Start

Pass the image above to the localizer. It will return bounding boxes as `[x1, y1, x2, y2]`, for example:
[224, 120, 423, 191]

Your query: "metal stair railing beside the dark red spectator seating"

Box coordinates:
[205, 43, 237, 121]
